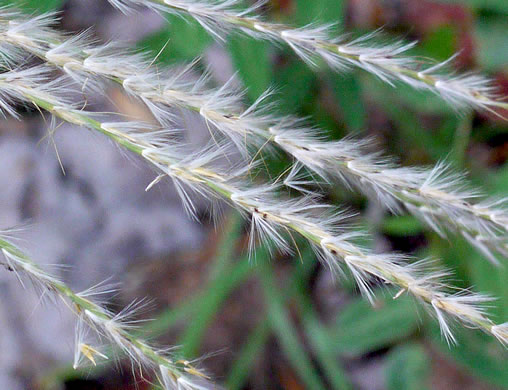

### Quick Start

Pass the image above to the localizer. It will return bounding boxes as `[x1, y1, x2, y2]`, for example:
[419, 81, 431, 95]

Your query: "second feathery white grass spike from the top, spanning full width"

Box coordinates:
[0, 10, 508, 264]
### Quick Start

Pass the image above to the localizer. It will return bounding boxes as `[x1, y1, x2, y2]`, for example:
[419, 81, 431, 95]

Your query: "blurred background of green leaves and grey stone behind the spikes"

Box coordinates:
[0, 0, 508, 390]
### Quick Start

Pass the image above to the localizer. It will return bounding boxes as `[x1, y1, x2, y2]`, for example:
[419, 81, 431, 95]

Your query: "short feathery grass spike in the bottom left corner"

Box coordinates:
[0, 233, 216, 390]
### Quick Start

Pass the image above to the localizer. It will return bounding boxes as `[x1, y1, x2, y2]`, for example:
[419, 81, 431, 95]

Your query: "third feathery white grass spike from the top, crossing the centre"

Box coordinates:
[0, 66, 504, 348]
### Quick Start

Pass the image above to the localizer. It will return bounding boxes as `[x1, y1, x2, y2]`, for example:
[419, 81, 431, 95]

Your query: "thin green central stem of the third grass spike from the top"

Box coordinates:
[0, 71, 495, 342]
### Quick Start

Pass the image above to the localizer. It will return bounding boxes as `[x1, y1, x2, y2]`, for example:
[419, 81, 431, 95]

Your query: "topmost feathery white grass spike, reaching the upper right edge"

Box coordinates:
[104, 0, 508, 112]
